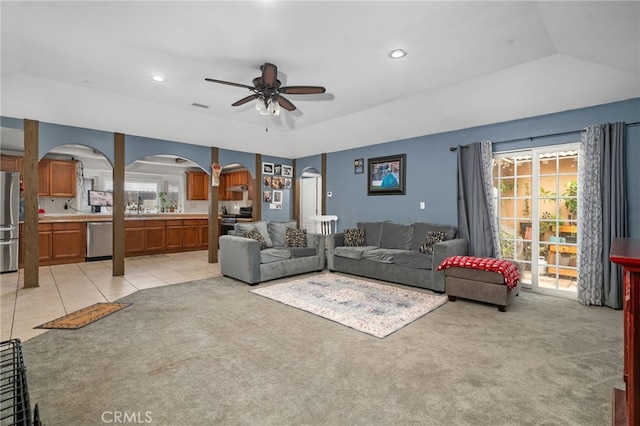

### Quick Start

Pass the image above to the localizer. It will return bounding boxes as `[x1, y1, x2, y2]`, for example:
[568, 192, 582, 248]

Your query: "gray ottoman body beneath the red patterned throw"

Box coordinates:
[444, 266, 520, 312]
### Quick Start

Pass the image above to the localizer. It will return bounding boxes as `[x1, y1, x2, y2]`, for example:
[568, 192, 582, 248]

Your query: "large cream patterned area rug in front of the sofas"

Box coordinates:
[250, 274, 447, 338]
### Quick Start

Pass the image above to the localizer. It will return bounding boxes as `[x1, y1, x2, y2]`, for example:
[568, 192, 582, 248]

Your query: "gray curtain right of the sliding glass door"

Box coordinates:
[578, 123, 627, 309]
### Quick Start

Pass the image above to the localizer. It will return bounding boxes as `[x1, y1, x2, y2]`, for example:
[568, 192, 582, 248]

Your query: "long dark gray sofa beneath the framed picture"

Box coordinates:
[327, 222, 469, 293]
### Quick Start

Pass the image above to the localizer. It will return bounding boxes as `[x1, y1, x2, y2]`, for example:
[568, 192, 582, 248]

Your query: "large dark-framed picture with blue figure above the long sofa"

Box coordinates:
[367, 154, 407, 195]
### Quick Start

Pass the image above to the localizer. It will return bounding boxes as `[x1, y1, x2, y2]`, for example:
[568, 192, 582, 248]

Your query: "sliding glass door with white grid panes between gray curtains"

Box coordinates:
[493, 144, 578, 298]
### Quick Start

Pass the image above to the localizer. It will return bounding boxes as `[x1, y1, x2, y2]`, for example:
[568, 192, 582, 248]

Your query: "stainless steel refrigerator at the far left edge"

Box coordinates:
[0, 172, 20, 272]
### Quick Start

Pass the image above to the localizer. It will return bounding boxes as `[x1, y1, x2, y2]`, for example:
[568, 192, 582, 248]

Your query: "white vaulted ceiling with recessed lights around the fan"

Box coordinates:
[0, 0, 640, 158]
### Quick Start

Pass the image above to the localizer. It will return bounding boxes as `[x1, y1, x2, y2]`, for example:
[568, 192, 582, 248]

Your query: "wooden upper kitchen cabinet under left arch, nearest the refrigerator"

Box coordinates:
[38, 158, 76, 198]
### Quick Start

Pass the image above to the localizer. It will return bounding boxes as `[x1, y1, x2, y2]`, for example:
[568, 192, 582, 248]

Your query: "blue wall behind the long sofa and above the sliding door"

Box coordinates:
[324, 98, 640, 238]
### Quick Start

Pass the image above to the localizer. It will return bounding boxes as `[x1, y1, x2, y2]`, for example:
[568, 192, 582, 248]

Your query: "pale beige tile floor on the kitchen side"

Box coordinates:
[0, 250, 220, 342]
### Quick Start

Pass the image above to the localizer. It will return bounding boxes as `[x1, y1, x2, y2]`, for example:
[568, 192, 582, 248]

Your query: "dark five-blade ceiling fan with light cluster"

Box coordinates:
[205, 62, 326, 115]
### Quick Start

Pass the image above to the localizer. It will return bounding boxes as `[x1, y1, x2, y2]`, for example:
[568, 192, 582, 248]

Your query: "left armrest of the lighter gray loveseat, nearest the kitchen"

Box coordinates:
[218, 235, 260, 284]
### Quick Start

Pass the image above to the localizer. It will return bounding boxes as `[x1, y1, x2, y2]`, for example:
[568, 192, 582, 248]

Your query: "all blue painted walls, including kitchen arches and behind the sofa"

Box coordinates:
[0, 98, 640, 238]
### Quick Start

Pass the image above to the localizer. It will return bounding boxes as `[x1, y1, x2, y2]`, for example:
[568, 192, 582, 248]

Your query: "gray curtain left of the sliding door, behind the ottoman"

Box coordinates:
[458, 141, 501, 258]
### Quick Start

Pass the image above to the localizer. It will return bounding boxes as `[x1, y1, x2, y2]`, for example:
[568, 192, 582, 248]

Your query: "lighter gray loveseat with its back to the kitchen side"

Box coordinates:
[218, 220, 325, 285]
